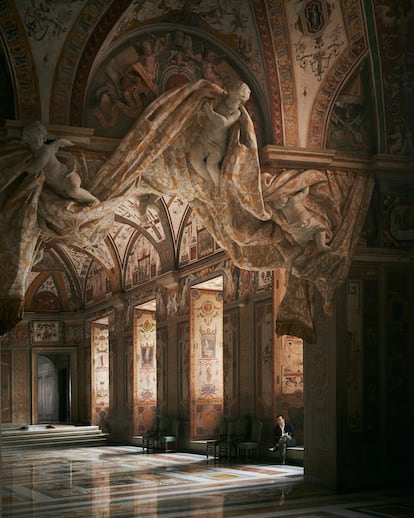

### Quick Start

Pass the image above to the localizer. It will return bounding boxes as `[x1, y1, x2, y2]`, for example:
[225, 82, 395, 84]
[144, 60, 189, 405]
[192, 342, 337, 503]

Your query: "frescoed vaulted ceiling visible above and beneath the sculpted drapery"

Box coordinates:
[0, 0, 414, 309]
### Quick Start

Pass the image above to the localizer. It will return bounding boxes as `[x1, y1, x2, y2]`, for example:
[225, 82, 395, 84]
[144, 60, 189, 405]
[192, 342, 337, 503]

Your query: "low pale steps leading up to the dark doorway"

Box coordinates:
[1, 425, 108, 450]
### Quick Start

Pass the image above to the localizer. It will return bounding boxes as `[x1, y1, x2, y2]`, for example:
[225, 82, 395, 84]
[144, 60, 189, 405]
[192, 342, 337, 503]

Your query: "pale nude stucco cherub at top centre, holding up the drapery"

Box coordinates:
[189, 81, 250, 192]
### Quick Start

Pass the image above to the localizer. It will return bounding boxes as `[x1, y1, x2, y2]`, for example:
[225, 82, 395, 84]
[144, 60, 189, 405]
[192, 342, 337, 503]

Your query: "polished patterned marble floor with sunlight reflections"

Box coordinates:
[0, 446, 414, 518]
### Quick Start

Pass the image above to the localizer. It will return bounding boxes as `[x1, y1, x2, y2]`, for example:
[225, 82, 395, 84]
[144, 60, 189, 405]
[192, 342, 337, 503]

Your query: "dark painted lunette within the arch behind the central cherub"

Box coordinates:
[82, 23, 273, 144]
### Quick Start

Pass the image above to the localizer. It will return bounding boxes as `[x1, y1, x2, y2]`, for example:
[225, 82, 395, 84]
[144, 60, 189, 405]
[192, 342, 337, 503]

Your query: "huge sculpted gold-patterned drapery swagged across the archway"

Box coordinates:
[0, 80, 373, 341]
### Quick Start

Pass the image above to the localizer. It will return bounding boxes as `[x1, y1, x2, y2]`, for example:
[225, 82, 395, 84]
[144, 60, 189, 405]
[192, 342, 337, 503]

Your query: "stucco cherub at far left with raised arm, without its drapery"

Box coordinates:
[22, 122, 99, 205]
